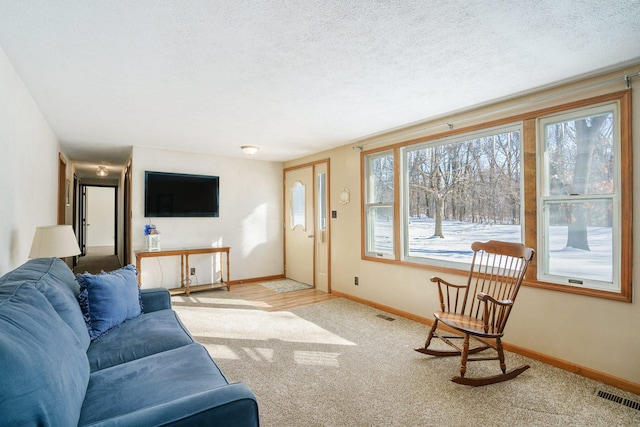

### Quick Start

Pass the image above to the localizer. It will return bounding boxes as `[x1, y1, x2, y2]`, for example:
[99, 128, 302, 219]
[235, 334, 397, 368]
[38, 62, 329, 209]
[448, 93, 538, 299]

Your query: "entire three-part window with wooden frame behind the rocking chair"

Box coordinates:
[362, 91, 632, 301]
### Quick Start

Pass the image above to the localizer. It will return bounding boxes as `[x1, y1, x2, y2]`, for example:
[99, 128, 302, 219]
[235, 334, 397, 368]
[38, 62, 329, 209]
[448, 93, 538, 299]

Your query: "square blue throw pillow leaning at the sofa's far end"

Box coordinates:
[76, 265, 142, 341]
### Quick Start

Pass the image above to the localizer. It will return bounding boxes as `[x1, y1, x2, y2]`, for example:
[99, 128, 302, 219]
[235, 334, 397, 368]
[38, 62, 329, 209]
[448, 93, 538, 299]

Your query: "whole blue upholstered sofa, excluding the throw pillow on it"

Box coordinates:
[0, 258, 259, 426]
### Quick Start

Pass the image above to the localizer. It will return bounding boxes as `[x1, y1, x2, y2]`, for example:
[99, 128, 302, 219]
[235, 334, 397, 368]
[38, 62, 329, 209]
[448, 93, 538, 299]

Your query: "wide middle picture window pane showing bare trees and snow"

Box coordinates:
[402, 125, 522, 265]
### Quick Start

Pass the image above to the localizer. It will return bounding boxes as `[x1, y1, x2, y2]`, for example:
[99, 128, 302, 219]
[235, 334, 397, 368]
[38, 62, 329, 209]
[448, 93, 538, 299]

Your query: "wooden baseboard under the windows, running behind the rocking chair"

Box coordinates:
[331, 290, 640, 395]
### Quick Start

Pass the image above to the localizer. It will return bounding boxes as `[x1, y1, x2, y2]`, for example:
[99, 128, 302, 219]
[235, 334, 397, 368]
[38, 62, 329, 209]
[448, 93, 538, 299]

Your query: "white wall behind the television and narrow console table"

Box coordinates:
[132, 147, 283, 288]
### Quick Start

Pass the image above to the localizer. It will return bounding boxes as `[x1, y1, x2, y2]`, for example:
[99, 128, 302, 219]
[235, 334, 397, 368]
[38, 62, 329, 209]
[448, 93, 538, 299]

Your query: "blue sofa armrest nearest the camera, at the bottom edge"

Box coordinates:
[85, 383, 260, 427]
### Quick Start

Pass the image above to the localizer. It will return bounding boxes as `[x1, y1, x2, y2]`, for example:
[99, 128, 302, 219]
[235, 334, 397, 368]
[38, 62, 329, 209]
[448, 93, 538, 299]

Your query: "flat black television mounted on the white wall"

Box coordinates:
[144, 171, 219, 217]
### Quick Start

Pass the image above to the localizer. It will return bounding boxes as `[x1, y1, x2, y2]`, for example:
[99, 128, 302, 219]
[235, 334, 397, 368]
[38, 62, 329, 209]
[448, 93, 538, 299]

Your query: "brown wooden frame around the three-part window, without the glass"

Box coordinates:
[360, 89, 633, 302]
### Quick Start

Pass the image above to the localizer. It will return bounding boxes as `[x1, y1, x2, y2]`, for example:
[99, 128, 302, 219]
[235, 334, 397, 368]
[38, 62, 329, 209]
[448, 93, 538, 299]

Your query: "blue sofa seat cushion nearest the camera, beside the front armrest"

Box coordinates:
[79, 343, 248, 425]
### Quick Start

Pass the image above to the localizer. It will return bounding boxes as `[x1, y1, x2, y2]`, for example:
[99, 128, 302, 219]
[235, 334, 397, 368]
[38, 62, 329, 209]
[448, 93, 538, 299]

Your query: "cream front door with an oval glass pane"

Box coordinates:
[284, 166, 315, 286]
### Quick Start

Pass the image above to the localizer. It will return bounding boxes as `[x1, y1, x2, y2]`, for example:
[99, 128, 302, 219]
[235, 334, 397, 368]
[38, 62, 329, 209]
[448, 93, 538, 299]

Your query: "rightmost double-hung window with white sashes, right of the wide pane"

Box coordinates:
[538, 103, 620, 291]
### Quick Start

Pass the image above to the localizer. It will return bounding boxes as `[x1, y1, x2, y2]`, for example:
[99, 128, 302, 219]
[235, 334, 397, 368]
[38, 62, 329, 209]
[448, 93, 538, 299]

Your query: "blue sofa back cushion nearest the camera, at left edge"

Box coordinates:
[0, 282, 89, 426]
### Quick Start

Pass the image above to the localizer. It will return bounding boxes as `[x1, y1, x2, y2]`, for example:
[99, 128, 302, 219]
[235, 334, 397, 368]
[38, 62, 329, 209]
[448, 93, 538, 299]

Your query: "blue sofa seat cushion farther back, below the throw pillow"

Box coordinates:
[87, 310, 194, 372]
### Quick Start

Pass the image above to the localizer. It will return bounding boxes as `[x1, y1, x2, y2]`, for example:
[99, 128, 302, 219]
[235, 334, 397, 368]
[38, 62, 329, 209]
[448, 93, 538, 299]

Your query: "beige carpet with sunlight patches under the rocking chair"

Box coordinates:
[172, 291, 640, 427]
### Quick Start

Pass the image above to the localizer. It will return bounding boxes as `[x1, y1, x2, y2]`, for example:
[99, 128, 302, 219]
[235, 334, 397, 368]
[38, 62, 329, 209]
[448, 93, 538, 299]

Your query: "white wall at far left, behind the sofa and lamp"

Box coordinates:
[0, 49, 60, 274]
